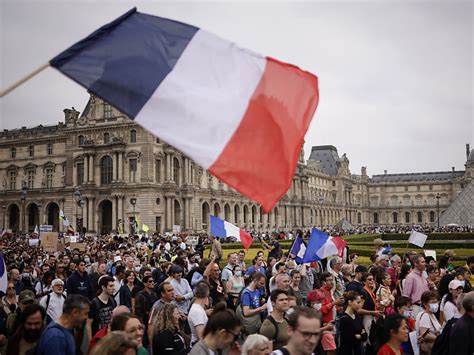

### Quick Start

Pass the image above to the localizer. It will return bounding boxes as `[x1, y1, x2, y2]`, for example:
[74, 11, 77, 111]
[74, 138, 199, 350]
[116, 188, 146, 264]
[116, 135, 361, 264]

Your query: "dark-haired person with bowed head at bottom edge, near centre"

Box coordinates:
[189, 306, 241, 355]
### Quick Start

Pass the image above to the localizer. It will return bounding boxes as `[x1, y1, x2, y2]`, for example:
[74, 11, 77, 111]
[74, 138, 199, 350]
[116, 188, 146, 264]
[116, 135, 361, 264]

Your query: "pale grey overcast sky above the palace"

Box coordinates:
[0, 0, 474, 175]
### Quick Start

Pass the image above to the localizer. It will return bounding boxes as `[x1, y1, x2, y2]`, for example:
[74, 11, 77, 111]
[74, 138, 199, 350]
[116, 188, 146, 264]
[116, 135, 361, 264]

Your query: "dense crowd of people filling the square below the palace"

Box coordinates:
[0, 231, 474, 355]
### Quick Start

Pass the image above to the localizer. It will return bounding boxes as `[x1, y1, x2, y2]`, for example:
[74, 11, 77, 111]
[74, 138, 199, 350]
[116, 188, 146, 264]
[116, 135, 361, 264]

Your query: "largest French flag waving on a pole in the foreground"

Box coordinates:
[50, 9, 319, 212]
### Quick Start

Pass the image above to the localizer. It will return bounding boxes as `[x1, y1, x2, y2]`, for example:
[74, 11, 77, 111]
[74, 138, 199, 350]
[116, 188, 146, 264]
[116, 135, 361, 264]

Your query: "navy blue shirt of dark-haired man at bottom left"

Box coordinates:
[36, 322, 76, 355]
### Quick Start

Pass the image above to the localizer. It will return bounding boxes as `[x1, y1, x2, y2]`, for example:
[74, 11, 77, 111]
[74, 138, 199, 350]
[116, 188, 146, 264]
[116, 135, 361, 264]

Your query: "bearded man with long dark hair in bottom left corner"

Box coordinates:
[6, 304, 46, 355]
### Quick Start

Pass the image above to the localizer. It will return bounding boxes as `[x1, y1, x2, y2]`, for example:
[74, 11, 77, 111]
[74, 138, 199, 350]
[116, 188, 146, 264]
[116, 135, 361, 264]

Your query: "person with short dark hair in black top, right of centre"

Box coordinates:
[337, 291, 367, 355]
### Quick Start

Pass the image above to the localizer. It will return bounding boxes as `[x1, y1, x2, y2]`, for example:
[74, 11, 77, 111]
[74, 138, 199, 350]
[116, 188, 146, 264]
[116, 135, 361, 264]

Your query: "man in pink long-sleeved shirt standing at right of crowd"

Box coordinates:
[402, 254, 429, 316]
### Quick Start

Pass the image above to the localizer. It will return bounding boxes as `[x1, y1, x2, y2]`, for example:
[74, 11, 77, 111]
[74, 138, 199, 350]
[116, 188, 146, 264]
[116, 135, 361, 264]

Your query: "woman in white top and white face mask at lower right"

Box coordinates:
[416, 291, 441, 354]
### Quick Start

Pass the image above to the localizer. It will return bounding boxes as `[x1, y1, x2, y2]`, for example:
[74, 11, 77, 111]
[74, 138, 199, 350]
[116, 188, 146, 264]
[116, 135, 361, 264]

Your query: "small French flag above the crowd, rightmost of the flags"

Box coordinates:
[303, 227, 346, 263]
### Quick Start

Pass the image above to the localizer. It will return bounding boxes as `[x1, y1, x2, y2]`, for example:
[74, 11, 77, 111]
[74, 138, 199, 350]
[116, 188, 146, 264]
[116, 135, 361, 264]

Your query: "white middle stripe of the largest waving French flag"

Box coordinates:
[135, 30, 266, 169]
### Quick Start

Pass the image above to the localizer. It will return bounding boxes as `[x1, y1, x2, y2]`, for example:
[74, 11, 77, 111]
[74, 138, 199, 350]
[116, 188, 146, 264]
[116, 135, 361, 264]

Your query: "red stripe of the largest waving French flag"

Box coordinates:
[209, 58, 319, 212]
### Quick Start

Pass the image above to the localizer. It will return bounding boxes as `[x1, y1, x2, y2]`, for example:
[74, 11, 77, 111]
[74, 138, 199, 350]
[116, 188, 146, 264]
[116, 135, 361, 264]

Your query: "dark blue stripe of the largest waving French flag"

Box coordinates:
[50, 8, 199, 118]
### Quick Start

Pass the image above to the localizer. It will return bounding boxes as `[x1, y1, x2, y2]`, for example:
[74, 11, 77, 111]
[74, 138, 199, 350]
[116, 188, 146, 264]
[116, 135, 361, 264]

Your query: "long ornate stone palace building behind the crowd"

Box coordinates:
[0, 95, 474, 233]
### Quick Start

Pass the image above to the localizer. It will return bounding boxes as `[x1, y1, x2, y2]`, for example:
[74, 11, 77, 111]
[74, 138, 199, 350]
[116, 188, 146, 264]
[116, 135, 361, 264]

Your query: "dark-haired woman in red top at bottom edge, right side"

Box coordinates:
[377, 313, 408, 355]
